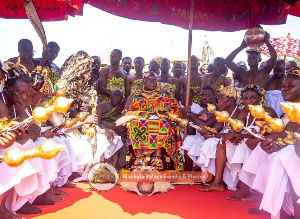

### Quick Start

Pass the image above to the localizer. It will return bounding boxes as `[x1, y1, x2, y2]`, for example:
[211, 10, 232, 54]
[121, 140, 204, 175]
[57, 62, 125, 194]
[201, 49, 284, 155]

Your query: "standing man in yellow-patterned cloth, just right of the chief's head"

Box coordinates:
[157, 58, 180, 100]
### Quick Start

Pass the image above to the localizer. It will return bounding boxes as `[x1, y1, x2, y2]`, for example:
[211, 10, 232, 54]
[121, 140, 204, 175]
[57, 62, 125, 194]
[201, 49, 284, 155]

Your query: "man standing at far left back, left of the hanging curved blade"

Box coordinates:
[7, 39, 34, 72]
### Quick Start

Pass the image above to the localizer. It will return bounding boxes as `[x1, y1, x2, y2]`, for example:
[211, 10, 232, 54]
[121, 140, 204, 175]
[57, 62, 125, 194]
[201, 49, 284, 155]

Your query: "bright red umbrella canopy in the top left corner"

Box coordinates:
[0, 0, 84, 21]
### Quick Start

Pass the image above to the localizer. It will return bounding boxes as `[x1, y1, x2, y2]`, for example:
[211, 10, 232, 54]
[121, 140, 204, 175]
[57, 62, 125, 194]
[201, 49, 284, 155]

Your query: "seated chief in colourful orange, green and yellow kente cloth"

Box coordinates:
[125, 71, 183, 170]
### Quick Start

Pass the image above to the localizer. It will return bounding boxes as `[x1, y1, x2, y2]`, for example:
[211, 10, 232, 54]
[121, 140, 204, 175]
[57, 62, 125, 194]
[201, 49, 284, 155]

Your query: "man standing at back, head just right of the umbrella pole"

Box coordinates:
[179, 55, 203, 104]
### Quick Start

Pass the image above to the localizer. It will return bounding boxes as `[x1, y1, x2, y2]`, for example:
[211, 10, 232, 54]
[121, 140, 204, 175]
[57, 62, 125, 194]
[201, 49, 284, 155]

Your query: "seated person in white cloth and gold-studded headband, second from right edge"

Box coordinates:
[198, 84, 277, 193]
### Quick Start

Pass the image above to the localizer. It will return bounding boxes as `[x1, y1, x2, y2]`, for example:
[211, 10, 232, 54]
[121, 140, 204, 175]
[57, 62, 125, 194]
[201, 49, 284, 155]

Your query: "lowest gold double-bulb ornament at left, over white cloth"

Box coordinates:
[3, 140, 66, 167]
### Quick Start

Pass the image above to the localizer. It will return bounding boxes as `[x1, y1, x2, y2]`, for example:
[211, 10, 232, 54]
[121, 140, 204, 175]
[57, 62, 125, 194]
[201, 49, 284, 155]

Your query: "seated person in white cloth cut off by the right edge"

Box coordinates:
[240, 70, 300, 218]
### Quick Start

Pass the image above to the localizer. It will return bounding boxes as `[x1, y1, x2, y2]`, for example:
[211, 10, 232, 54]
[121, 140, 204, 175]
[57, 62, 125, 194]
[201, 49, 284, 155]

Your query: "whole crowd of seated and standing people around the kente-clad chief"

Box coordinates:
[0, 34, 300, 218]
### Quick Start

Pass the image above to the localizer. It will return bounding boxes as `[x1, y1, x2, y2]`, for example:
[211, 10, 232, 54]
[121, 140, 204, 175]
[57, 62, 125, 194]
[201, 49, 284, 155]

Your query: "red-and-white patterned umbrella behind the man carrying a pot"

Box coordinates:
[261, 33, 300, 60]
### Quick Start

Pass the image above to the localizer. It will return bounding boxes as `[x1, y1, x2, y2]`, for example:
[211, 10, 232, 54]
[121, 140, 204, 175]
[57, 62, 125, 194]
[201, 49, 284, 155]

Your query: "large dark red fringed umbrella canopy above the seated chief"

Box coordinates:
[88, 0, 297, 31]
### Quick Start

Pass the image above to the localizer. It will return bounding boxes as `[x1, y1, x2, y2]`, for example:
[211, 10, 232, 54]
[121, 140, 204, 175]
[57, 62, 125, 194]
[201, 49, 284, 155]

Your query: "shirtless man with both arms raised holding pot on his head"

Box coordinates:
[225, 33, 277, 87]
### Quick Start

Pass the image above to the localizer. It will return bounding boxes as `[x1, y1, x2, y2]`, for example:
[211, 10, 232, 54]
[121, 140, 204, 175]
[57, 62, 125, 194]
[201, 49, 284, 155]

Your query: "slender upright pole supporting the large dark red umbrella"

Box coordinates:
[184, 0, 194, 137]
